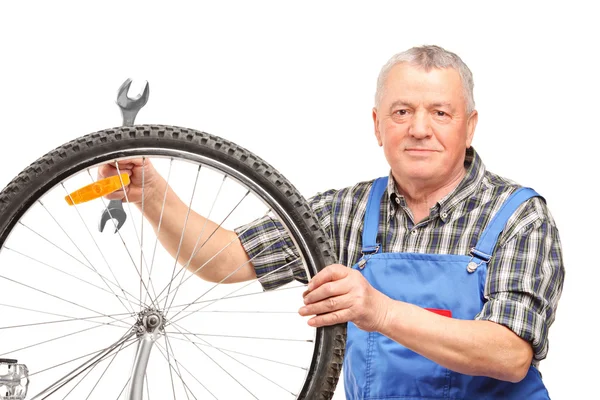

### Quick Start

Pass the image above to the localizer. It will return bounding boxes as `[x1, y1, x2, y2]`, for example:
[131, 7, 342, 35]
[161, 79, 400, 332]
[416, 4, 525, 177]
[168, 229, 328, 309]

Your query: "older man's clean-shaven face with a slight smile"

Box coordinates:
[373, 64, 477, 187]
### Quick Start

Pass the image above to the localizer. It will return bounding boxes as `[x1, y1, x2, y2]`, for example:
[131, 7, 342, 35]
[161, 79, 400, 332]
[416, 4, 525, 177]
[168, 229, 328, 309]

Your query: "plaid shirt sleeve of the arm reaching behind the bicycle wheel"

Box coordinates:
[235, 190, 335, 290]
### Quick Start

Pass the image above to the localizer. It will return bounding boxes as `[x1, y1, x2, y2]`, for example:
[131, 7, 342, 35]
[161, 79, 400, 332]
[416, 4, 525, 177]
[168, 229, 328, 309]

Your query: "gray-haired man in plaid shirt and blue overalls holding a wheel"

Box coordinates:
[101, 46, 564, 399]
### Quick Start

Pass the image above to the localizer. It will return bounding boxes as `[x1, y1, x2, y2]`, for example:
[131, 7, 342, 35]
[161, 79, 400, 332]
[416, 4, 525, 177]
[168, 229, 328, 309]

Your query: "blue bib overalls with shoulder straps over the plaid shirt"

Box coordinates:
[344, 177, 549, 400]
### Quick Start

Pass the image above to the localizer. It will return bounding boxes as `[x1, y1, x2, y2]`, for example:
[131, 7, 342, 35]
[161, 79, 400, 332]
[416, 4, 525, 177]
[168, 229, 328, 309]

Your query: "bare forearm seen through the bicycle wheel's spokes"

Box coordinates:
[136, 181, 256, 283]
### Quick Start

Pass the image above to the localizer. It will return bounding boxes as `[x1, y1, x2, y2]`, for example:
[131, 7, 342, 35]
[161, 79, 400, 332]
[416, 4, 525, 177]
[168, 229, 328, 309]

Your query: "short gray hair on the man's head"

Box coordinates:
[375, 45, 475, 114]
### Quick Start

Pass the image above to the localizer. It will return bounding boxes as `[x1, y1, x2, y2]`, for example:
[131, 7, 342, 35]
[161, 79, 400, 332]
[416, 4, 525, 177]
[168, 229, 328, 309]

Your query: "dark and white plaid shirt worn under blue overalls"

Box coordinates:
[236, 148, 564, 364]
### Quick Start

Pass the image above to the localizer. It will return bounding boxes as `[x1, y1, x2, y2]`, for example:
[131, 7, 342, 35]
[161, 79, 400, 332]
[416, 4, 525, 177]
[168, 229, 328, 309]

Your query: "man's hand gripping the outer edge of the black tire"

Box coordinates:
[298, 264, 390, 332]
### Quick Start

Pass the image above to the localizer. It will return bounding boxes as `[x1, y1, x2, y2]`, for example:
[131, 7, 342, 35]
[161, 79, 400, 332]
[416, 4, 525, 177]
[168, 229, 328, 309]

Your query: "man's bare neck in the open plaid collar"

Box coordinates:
[394, 168, 466, 224]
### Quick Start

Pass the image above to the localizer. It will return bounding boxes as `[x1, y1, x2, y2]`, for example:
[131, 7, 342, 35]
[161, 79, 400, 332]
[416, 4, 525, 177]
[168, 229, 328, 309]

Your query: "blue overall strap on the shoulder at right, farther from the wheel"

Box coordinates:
[471, 187, 543, 263]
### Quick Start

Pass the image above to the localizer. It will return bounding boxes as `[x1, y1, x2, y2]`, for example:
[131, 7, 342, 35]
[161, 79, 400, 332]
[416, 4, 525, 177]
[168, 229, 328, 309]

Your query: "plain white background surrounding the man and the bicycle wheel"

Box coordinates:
[0, 1, 600, 400]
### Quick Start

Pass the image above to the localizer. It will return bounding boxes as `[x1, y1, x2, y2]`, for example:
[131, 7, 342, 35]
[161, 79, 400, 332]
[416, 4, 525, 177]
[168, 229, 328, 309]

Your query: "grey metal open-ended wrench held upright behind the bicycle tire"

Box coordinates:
[98, 78, 150, 233]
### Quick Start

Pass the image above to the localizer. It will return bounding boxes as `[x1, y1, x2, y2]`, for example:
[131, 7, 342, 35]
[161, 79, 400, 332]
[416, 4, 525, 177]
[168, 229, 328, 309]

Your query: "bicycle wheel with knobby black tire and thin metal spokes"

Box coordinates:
[0, 125, 345, 399]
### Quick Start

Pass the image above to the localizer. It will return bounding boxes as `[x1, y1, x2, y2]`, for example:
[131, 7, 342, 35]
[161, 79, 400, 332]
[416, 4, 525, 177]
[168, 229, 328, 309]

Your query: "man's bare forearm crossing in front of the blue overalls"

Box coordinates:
[377, 298, 533, 382]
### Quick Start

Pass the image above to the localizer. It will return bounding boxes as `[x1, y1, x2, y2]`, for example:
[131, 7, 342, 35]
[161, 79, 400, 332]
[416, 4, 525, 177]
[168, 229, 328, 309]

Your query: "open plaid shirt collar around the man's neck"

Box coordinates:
[387, 146, 486, 222]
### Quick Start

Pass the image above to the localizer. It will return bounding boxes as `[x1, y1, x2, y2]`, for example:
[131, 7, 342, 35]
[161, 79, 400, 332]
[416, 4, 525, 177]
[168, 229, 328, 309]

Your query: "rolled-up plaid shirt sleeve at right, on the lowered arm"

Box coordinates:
[476, 198, 565, 364]
